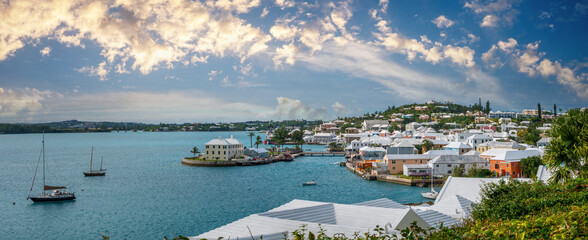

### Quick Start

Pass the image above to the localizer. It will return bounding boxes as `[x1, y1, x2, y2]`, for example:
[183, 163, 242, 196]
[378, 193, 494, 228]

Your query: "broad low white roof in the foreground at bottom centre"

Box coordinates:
[192, 198, 458, 239]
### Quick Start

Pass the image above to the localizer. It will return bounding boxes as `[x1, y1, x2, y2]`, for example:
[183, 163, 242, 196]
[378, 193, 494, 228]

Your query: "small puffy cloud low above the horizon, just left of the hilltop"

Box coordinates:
[276, 97, 328, 120]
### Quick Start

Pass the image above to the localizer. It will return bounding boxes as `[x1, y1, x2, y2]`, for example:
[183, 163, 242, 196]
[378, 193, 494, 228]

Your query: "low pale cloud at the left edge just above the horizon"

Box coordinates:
[0, 88, 54, 118]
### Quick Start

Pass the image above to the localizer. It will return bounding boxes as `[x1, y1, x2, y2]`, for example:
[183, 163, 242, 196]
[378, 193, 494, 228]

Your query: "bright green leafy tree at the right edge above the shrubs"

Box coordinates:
[543, 109, 588, 183]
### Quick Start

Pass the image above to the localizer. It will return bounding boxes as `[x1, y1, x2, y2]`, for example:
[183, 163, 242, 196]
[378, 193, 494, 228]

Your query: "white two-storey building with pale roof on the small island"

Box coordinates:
[204, 135, 244, 161]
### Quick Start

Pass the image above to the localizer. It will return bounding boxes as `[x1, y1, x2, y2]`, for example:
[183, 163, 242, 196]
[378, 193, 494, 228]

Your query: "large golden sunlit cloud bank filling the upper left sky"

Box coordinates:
[0, 0, 271, 74]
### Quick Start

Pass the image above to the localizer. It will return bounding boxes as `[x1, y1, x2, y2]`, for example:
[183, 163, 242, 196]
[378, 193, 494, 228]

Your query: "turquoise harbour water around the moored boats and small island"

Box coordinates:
[0, 132, 426, 239]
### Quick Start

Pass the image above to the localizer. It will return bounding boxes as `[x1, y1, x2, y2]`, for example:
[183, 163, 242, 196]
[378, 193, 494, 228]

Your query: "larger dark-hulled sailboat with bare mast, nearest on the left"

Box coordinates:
[27, 134, 76, 202]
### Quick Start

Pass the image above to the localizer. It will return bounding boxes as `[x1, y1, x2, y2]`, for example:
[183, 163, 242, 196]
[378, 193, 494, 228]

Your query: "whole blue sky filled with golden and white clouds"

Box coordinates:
[0, 0, 588, 123]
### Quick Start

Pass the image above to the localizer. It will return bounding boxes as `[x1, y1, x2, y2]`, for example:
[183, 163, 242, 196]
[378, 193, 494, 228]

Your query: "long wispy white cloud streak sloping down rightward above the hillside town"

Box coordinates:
[300, 42, 499, 101]
